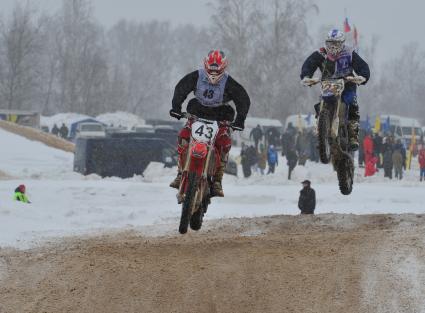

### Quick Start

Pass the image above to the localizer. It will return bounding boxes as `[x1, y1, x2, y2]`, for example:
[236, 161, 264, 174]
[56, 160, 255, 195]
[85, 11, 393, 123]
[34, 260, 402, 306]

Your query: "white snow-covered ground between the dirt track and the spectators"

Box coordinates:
[0, 125, 425, 247]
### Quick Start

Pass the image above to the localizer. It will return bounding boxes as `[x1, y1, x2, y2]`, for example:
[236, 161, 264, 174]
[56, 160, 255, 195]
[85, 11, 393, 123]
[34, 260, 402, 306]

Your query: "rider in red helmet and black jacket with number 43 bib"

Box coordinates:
[170, 50, 250, 197]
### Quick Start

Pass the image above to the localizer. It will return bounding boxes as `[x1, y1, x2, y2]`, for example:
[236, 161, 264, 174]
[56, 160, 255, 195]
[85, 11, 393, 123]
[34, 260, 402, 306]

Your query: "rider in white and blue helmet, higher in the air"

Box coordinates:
[301, 29, 370, 151]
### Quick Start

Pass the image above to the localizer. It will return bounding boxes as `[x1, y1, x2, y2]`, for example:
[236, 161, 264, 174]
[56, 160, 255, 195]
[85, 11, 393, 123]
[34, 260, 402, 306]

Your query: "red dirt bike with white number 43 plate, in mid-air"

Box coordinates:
[177, 113, 231, 234]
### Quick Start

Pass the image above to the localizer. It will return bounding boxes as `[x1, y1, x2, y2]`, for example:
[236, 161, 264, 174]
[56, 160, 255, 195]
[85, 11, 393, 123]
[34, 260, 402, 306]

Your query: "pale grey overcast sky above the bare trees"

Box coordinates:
[0, 0, 425, 66]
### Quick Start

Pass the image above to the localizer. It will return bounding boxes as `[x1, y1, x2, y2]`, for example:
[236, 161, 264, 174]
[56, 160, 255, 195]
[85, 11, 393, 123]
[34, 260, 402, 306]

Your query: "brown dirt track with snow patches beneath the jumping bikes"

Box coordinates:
[0, 214, 425, 313]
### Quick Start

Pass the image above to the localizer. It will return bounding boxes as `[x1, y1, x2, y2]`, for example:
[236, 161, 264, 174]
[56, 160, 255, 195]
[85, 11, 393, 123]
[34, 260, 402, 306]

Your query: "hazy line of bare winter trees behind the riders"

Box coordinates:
[0, 0, 424, 119]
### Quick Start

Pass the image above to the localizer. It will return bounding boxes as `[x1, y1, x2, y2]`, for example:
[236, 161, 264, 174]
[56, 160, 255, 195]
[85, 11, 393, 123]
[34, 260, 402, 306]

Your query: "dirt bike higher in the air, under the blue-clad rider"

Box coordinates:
[309, 77, 362, 195]
